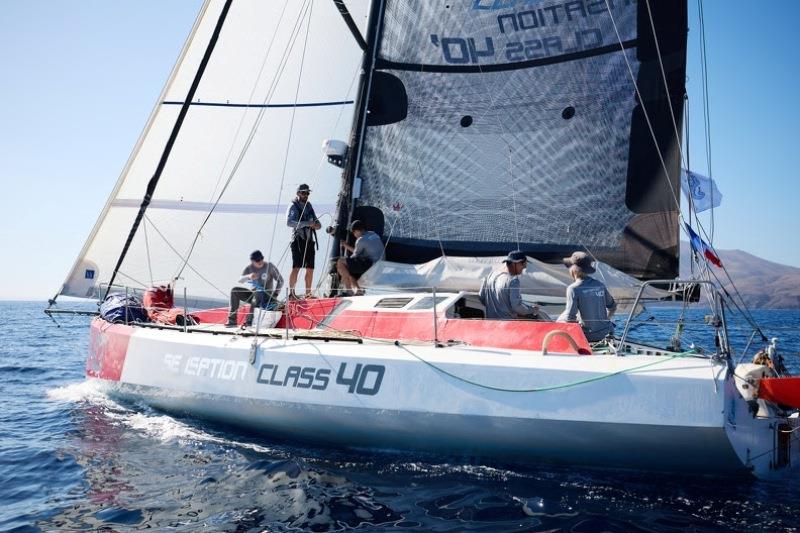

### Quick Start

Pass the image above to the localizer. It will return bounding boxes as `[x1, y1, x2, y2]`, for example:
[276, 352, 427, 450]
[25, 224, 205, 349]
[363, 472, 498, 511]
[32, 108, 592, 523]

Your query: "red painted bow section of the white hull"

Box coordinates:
[86, 318, 133, 381]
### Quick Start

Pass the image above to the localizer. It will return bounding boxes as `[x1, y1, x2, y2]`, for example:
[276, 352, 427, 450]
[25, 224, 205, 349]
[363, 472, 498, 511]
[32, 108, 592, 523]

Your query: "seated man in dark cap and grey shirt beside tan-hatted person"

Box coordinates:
[478, 250, 539, 320]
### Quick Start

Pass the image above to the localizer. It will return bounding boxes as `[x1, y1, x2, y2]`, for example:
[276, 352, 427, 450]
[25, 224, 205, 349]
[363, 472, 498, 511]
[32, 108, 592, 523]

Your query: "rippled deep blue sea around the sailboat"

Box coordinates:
[0, 302, 800, 532]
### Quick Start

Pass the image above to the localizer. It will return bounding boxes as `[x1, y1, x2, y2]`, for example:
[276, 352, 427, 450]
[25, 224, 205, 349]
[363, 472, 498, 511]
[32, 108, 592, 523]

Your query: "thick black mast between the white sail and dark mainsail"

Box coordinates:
[330, 0, 384, 290]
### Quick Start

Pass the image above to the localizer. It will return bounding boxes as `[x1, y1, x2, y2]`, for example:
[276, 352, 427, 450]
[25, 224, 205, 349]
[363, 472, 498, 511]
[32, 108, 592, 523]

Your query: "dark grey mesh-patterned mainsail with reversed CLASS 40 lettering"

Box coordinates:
[346, 0, 687, 279]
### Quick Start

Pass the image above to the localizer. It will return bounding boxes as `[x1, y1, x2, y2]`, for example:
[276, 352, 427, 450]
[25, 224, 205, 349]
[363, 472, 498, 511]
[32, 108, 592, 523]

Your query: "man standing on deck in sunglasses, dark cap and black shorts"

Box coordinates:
[286, 183, 322, 298]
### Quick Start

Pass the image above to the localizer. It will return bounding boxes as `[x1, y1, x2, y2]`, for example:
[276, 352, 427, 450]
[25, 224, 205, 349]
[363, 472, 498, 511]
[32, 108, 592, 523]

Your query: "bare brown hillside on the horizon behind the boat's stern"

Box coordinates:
[681, 242, 800, 309]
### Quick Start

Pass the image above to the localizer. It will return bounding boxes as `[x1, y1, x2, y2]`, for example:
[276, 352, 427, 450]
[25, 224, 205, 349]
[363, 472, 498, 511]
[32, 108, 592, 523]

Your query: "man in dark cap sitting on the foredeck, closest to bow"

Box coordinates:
[227, 250, 283, 327]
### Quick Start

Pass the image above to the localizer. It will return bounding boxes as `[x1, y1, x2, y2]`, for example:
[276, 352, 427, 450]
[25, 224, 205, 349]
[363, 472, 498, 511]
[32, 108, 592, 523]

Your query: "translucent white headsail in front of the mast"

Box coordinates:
[61, 0, 368, 300]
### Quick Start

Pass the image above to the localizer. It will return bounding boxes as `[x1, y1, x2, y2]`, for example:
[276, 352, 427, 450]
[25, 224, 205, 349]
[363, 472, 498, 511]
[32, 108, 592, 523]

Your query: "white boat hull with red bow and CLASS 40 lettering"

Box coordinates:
[87, 319, 800, 476]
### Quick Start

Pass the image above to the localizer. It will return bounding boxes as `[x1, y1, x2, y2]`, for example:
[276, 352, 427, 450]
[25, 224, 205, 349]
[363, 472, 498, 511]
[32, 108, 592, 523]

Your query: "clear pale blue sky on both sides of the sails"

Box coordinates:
[0, 0, 800, 300]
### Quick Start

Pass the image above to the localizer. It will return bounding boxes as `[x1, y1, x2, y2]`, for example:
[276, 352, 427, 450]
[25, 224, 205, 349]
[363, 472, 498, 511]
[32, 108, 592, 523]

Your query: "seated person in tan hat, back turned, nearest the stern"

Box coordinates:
[557, 252, 617, 342]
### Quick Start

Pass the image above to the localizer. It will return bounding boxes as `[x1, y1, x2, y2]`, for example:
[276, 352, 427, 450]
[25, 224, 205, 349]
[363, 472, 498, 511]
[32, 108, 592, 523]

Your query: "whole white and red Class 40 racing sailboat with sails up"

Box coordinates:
[49, 0, 800, 476]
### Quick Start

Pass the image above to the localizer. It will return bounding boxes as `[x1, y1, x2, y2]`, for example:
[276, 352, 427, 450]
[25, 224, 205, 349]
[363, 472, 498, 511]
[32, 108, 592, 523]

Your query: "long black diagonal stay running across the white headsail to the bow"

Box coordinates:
[103, 0, 233, 299]
